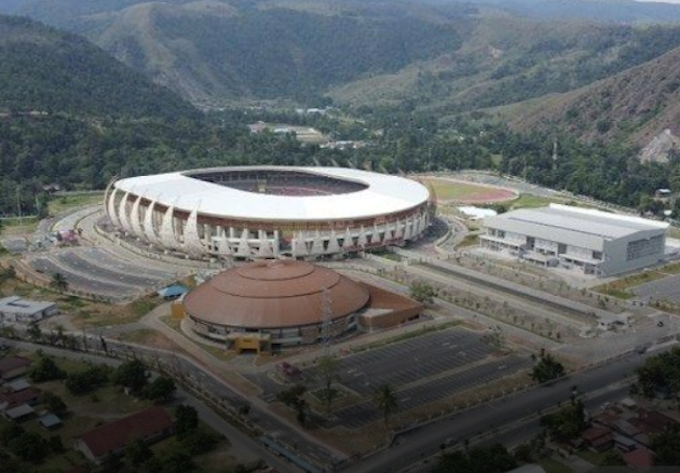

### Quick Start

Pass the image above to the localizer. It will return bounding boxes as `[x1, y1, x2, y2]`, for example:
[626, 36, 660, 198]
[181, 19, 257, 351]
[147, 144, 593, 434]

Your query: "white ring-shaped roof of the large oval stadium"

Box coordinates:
[115, 166, 430, 221]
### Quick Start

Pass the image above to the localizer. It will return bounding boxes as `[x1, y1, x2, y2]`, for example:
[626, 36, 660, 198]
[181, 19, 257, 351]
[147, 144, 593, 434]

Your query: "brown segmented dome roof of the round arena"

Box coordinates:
[184, 260, 369, 328]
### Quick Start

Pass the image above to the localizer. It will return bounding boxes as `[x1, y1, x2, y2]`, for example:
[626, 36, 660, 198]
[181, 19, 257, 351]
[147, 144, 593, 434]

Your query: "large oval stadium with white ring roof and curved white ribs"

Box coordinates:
[105, 166, 434, 260]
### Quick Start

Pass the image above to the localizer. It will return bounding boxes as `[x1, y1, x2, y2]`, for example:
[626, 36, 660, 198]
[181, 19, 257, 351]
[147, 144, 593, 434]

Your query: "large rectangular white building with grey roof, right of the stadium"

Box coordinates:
[480, 204, 668, 276]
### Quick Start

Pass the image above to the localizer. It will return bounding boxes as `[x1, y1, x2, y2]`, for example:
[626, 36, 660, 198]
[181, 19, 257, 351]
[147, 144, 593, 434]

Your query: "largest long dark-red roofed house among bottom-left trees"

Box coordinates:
[75, 406, 174, 463]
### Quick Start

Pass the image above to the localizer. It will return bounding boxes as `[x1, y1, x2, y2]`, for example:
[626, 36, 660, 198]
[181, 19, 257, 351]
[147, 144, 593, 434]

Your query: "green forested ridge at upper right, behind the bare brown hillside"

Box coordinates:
[329, 15, 680, 115]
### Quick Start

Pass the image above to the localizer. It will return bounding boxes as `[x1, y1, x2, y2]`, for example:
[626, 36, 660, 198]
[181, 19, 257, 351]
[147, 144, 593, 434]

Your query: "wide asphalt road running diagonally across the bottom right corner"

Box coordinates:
[344, 346, 650, 473]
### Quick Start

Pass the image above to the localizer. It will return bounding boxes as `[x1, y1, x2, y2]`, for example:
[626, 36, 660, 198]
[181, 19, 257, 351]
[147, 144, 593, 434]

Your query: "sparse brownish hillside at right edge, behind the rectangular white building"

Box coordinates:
[505, 48, 680, 160]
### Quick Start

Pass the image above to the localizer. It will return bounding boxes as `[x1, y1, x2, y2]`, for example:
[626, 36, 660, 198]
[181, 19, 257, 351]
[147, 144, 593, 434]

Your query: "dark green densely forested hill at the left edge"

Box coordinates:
[0, 15, 197, 118]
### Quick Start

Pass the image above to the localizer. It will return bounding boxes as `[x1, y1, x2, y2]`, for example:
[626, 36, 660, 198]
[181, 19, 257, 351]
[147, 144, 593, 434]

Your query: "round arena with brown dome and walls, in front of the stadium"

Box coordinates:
[183, 260, 370, 351]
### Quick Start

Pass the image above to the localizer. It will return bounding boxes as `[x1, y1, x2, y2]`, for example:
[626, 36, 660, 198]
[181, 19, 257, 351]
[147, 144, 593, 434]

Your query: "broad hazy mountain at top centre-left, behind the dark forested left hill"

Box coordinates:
[1, 0, 472, 106]
